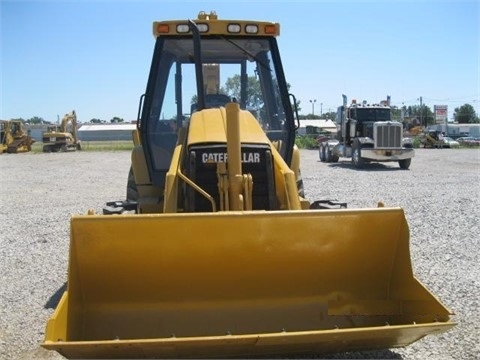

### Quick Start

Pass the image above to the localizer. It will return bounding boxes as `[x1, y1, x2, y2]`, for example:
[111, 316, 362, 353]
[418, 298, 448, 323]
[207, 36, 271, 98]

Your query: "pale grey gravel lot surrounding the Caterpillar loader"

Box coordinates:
[0, 149, 480, 359]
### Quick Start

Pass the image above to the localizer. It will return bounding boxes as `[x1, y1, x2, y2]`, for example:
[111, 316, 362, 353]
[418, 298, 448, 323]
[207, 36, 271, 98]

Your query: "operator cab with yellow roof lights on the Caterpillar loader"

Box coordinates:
[139, 14, 296, 186]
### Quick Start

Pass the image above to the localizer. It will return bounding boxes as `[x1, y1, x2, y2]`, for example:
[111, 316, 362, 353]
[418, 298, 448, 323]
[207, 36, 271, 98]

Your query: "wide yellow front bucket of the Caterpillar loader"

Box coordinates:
[42, 208, 454, 358]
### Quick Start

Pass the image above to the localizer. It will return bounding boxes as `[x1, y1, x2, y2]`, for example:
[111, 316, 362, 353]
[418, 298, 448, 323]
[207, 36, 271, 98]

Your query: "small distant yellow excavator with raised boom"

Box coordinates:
[42, 110, 82, 152]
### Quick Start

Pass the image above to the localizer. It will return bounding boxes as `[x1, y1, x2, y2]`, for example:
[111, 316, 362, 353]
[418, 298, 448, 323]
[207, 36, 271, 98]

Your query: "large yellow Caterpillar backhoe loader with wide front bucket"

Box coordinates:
[42, 12, 455, 358]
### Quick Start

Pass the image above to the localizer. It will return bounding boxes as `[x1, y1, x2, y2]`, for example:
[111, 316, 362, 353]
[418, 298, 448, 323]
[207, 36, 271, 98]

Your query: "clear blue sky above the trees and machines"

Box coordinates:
[0, 0, 480, 122]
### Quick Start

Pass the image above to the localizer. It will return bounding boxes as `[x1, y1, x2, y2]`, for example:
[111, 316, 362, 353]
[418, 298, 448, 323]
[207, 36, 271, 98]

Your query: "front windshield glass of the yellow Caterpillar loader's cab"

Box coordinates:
[141, 36, 295, 183]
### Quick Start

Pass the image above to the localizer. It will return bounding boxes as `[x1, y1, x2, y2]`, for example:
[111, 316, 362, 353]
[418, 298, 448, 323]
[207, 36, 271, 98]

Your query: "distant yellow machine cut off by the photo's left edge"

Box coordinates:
[0, 120, 35, 154]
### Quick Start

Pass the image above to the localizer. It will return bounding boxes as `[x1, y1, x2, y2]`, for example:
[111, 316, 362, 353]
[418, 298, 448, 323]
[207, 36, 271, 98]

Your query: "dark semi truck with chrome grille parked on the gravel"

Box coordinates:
[319, 95, 415, 169]
